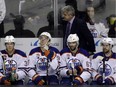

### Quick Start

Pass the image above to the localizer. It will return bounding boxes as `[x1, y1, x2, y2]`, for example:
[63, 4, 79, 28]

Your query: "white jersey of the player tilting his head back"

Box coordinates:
[28, 46, 60, 79]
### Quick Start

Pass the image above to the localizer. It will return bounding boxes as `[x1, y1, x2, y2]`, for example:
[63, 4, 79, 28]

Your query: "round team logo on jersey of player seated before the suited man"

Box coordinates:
[67, 58, 82, 69]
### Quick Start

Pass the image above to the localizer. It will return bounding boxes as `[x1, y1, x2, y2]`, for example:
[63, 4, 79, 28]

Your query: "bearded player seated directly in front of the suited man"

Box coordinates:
[60, 34, 91, 85]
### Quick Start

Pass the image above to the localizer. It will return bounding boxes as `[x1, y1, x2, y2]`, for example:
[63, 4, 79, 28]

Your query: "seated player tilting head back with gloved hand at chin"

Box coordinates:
[28, 32, 60, 85]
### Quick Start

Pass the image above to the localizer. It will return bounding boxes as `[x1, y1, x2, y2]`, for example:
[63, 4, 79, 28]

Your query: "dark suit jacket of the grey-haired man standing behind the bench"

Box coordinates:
[64, 17, 95, 52]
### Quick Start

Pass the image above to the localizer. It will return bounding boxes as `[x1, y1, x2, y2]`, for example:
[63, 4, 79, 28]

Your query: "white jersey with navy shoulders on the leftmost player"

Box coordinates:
[0, 49, 27, 80]
